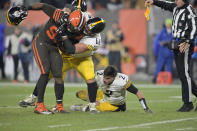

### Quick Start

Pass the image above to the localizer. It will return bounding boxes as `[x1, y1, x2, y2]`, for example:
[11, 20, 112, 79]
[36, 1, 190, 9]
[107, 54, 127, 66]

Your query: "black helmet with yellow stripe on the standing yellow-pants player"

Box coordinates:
[84, 17, 105, 36]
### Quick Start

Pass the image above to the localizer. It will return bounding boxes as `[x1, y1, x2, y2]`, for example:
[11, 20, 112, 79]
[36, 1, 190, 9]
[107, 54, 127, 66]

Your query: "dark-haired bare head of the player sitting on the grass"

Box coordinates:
[104, 65, 118, 77]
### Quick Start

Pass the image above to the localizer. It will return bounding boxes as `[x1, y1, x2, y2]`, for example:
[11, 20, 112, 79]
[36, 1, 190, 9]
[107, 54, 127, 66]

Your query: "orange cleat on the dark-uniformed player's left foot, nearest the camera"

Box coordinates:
[34, 102, 53, 115]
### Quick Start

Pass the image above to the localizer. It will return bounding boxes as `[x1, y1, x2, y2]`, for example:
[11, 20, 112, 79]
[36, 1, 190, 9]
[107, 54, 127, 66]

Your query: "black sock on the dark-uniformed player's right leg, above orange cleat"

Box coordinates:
[55, 83, 64, 104]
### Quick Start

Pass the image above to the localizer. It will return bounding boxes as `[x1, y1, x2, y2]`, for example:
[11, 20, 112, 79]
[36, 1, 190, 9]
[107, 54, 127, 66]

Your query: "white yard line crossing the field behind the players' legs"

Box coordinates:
[0, 82, 180, 89]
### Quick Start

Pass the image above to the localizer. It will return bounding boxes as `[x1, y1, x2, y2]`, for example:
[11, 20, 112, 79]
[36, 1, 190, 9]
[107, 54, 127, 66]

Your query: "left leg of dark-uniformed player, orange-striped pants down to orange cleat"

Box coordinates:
[32, 37, 52, 114]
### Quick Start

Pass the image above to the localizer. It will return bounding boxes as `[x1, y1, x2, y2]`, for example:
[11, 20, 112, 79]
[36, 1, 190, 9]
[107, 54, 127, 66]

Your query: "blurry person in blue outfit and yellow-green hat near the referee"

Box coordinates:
[153, 19, 173, 83]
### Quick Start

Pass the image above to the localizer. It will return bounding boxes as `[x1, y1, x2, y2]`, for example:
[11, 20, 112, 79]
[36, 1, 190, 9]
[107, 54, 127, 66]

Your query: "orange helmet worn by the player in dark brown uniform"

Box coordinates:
[67, 10, 86, 32]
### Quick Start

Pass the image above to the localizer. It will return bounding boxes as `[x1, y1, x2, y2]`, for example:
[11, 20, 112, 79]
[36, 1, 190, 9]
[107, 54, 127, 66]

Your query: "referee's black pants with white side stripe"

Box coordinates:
[174, 44, 197, 104]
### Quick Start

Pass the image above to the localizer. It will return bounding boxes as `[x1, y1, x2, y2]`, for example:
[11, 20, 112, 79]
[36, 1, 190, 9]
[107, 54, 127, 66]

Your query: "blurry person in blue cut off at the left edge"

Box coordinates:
[0, 24, 6, 79]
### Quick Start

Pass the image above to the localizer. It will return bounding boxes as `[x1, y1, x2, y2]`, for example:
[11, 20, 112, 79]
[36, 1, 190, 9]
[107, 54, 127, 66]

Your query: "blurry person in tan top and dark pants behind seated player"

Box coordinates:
[106, 22, 124, 72]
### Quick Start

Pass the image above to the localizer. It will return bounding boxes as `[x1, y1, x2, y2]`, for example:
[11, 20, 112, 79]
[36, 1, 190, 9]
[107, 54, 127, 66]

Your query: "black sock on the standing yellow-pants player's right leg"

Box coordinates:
[87, 82, 98, 102]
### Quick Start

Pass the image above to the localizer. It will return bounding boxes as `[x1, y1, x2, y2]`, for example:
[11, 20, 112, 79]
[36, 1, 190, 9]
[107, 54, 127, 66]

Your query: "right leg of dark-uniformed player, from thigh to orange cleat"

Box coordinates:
[50, 48, 67, 113]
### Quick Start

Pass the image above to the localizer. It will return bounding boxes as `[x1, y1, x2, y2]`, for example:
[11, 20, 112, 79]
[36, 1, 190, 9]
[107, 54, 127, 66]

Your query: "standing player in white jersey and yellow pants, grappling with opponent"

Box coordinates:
[19, 0, 105, 113]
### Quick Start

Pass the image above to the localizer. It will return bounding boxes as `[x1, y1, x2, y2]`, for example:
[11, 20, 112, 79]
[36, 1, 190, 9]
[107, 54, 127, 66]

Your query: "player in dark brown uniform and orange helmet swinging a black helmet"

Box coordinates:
[7, 3, 86, 114]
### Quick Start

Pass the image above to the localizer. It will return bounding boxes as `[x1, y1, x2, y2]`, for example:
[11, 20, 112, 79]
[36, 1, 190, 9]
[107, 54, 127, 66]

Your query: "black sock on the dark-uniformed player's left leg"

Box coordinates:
[36, 74, 49, 103]
